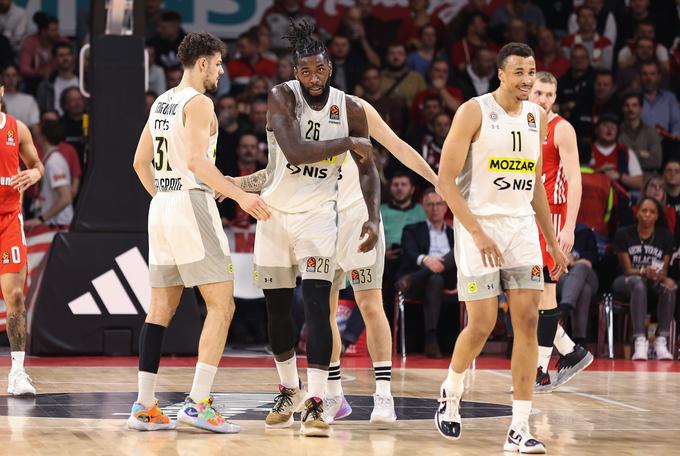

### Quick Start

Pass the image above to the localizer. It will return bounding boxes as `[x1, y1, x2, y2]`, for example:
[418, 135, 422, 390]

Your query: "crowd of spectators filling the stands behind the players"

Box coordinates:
[5, 0, 680, 356]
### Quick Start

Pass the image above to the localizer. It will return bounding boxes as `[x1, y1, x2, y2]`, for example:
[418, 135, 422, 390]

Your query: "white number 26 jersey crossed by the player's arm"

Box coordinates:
[262, 80, 349, 213]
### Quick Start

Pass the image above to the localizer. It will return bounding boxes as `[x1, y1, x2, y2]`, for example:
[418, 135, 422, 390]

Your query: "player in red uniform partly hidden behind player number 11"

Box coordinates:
[529, 71, 593, 393]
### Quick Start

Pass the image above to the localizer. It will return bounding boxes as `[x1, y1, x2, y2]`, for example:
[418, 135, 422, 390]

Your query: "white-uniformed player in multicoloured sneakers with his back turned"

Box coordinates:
[127, 33, 270, 433]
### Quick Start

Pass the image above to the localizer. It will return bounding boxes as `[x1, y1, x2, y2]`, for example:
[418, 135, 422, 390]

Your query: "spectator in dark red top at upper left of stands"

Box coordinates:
[19, 11, 66, 95]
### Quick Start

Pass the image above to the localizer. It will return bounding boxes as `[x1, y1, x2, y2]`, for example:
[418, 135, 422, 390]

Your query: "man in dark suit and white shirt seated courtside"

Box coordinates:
[397, 188, 456, 358]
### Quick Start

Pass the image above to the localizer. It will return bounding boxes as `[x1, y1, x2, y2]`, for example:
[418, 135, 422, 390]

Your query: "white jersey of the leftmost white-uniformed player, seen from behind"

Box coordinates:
[148, 87, 217, 192]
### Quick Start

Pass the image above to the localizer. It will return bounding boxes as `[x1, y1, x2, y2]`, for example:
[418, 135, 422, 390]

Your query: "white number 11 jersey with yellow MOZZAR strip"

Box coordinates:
[456, 93, 541, 217]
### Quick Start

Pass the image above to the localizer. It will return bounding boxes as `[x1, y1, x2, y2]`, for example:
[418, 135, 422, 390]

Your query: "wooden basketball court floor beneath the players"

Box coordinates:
[0, 358, 680, 456]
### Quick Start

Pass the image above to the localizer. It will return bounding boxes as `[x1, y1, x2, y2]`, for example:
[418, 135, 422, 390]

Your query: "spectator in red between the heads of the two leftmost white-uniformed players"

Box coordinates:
[227, 31, 276, 95]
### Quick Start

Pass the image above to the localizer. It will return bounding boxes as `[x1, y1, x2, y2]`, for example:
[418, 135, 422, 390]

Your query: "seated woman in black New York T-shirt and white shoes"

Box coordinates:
[612, 197, 677, 360]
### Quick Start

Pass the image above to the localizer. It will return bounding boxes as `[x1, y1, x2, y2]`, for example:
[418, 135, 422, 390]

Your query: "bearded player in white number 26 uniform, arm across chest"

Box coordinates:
[254, 22, 380, 437]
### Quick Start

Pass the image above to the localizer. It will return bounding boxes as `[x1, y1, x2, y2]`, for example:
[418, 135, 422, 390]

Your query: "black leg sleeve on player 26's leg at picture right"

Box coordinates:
[302, 279, 333, 366]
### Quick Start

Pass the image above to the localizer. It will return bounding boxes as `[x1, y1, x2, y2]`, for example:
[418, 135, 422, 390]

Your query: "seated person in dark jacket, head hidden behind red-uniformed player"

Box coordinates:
[557, 223, 599, 347]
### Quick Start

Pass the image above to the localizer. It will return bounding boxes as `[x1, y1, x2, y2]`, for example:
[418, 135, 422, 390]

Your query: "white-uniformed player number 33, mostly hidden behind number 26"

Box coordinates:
[233, 97, 437, 423]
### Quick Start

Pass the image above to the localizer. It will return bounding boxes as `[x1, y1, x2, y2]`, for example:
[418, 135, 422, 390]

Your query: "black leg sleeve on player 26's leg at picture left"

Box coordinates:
[262, 288, 297, 355]
